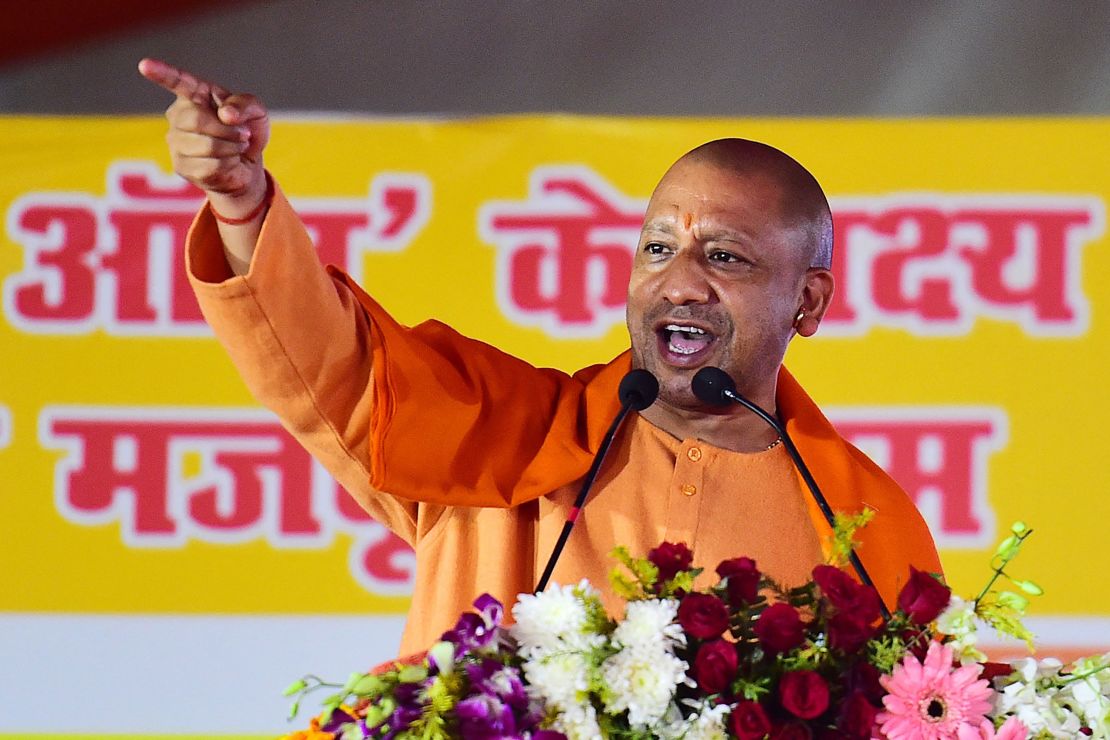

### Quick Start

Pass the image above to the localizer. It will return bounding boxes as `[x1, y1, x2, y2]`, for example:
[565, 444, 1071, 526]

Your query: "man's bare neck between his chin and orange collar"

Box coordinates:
[639, 393, 778, 453]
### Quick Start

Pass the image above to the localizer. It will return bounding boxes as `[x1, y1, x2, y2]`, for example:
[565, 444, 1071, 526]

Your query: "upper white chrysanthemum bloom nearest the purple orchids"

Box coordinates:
[509, 580, 597, 655]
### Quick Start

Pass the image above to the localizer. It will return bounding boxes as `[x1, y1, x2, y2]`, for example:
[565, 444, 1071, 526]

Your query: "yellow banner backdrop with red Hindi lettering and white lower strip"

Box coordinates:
[0, 116, 1110, 738]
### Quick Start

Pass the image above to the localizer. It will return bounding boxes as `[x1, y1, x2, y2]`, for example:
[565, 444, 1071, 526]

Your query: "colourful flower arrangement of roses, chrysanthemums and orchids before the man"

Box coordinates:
[286, 516, 1110, 740]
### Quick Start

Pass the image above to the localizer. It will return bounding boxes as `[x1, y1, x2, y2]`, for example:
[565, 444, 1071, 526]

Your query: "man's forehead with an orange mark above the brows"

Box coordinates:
[644, 161, 784, 230]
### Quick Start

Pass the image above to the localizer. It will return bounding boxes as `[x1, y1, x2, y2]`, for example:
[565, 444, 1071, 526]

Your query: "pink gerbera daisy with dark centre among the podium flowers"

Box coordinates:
[877, 642, 991, 740]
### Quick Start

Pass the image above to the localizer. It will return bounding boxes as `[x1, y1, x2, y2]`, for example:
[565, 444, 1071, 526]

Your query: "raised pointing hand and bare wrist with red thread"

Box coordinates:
[139, 59, 272, 275]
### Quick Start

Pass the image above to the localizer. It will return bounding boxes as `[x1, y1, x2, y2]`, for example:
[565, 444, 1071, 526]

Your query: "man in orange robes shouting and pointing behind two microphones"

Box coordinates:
[140, 60, 940, 652]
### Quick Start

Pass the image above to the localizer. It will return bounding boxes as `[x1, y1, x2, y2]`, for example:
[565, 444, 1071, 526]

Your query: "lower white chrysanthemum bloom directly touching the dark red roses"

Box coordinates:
[602, 647, 687, 730]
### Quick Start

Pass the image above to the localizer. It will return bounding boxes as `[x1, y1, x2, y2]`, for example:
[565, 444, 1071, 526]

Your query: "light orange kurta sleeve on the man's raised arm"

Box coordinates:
[185, 184, 424, 544]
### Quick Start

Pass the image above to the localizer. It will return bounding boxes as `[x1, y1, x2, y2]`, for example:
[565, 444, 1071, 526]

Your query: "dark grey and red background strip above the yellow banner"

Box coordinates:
[0, 0, 1110, 116]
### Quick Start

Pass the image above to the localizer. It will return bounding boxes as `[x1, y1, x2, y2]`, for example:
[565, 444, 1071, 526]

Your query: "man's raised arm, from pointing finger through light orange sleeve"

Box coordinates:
[139, 59, 430, 543]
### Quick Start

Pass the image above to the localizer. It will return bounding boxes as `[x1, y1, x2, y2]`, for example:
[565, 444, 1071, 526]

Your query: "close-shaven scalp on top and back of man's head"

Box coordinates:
[660, 139, 833, 270]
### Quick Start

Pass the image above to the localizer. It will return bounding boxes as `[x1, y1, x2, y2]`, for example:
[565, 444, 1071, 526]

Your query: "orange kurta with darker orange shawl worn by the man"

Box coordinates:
[186, 184, 940, 652]
